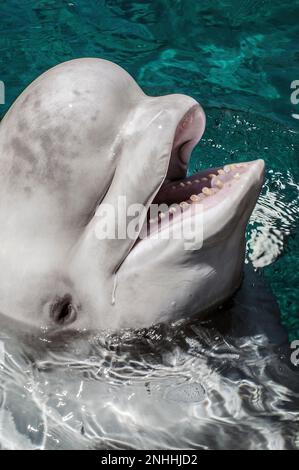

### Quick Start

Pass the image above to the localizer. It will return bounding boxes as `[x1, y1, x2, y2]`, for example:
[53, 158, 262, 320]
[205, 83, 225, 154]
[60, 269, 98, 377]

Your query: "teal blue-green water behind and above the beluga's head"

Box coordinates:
[0, 0, 299, 338]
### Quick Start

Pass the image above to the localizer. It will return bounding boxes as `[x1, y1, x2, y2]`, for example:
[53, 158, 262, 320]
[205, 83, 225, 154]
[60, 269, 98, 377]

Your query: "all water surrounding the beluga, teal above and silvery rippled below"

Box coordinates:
[0, 0, 299, 449]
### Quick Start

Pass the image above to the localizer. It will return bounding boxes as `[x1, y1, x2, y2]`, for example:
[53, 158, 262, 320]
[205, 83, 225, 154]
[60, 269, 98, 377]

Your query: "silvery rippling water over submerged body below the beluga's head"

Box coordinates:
[0, 268, 299, 449]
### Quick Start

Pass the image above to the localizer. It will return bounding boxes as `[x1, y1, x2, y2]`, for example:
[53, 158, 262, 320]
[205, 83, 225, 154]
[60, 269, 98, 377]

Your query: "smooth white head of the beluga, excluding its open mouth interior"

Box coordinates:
[0, 59, 263, 332]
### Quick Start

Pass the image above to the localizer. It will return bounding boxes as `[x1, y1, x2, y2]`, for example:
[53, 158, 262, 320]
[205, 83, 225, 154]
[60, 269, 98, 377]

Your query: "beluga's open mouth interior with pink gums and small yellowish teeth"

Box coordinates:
[141, 106, 264, 239]
